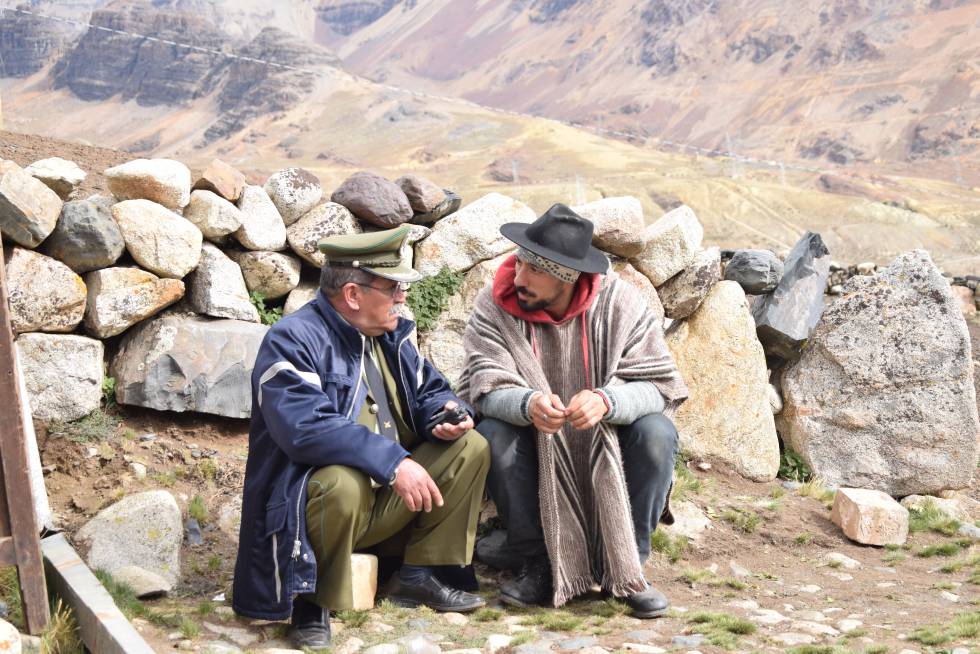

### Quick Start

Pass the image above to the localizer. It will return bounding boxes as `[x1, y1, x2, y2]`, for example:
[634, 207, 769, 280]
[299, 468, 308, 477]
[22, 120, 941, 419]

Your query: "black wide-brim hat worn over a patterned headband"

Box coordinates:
[500, 203, 609, 273]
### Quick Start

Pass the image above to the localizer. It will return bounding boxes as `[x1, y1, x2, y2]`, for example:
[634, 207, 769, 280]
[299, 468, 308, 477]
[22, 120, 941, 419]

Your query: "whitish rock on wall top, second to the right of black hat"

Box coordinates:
[631, 205, 704, 288]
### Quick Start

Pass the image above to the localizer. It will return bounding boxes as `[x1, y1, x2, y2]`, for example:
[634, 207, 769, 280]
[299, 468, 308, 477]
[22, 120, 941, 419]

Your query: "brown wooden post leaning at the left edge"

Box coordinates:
[0, 236, 50, 635]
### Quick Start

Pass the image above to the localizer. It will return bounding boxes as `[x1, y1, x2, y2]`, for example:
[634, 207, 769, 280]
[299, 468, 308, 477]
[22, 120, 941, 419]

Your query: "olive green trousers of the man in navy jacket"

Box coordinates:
[306, 430, 490, 610]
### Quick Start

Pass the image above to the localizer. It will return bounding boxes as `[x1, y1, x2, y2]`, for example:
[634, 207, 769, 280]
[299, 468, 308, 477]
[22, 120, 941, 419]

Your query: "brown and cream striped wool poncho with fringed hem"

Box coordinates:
[457, 266, 687, 606]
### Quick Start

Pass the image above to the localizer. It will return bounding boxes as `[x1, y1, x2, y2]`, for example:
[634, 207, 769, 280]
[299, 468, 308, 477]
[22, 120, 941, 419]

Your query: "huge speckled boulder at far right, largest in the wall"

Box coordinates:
[779, 250, 980, 497]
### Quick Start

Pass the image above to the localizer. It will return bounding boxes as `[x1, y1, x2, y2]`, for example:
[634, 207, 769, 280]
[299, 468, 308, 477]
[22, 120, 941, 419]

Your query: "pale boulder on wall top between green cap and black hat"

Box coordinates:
[415, 193, 537, 275]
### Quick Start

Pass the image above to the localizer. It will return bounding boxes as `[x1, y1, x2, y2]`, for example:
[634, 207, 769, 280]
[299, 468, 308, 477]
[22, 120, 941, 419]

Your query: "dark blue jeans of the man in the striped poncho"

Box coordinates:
[476, 413, 677, 561]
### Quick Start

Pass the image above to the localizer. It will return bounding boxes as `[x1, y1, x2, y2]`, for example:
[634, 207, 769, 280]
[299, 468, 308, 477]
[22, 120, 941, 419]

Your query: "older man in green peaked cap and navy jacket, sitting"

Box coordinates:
[233, 227, 489, 648]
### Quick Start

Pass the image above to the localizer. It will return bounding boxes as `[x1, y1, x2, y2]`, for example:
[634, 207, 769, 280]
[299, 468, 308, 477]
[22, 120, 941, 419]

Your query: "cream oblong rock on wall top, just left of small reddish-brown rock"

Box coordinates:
[105, 159, 191, 211]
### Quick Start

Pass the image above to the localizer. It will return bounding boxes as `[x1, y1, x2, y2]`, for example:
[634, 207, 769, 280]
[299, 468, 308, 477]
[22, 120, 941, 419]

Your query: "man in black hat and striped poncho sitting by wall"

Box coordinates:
[458, 204, 687, 618]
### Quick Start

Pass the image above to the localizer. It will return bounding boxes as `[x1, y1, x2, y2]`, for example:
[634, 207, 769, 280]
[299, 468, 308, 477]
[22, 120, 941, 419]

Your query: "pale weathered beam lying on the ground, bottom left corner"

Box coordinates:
[41, 534, 153, 654]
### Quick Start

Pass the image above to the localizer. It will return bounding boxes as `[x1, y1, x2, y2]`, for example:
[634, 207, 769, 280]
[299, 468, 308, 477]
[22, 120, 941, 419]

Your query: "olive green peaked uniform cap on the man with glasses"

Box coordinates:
[317, 225, 423, 282]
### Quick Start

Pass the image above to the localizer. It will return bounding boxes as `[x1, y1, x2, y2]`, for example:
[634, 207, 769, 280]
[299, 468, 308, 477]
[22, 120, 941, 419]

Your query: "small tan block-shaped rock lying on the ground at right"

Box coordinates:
[830, 488, 909, 545]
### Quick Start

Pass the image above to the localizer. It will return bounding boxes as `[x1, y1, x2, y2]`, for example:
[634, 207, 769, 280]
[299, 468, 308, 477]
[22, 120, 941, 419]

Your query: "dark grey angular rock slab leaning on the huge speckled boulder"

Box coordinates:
[752, 232, 830, 359]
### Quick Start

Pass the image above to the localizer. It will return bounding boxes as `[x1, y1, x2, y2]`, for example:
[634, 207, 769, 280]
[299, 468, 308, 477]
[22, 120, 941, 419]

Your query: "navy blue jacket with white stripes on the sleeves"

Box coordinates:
[232, 292, 473, 620]
